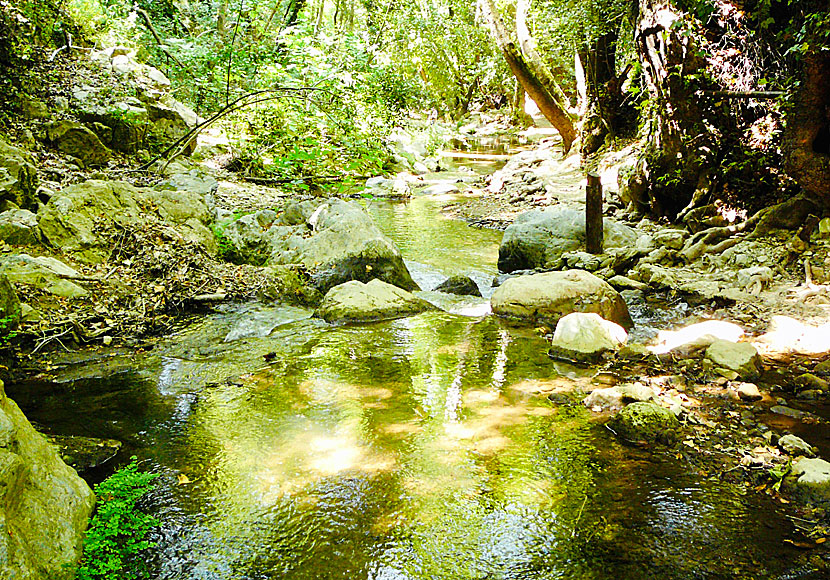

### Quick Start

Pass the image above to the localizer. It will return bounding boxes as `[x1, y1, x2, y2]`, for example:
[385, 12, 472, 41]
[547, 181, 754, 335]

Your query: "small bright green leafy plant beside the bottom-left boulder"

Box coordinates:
[77, 457, 159, 580]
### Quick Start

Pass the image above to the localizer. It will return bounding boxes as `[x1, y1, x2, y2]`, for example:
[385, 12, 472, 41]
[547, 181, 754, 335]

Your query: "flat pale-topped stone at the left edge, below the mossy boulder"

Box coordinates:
[0, 254, 88, 299]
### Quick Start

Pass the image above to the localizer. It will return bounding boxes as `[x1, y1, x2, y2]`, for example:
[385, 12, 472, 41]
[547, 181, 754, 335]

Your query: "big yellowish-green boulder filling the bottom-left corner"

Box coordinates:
[0, 383, 95, 580]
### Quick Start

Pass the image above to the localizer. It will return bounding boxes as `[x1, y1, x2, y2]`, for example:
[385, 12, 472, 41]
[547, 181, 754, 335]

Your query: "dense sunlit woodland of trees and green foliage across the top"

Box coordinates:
[0, 0, 830, 219]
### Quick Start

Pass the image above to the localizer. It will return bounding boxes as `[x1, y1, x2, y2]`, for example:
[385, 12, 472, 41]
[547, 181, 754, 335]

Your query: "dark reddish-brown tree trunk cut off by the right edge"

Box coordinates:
[784, 52, 830, 207]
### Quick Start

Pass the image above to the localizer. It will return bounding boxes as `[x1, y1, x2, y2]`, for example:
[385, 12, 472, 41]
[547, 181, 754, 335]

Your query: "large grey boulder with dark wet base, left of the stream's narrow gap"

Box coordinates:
[225, 199, 419, 293]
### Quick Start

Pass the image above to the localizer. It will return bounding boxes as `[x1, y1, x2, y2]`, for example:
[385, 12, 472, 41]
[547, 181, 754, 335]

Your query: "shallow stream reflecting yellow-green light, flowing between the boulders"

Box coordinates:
[6, 151, 820, 580]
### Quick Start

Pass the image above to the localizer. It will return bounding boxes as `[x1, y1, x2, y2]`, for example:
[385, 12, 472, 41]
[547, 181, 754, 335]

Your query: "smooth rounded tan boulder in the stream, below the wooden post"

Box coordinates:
[490, 270, 634, 329]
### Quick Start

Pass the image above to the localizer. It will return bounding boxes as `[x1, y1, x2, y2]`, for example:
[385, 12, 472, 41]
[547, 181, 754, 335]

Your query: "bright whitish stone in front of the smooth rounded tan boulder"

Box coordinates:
[550, 312, 628, 361]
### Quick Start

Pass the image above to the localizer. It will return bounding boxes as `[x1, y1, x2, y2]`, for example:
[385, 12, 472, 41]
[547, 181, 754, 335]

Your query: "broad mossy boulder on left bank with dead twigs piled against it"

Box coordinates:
[38, 180, 216, 263]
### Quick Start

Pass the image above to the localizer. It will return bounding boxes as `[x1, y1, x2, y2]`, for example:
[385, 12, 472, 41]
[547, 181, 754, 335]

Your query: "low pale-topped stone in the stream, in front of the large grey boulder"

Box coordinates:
[314, 279, 436, 324]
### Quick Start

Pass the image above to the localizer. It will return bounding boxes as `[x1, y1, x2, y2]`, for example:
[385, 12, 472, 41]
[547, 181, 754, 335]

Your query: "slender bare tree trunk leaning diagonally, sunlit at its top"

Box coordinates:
[479, 0, 576, 153]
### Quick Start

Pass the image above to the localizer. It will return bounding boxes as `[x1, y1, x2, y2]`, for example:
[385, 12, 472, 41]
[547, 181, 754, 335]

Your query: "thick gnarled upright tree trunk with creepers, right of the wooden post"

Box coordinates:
[621, 0, 716, 220]
